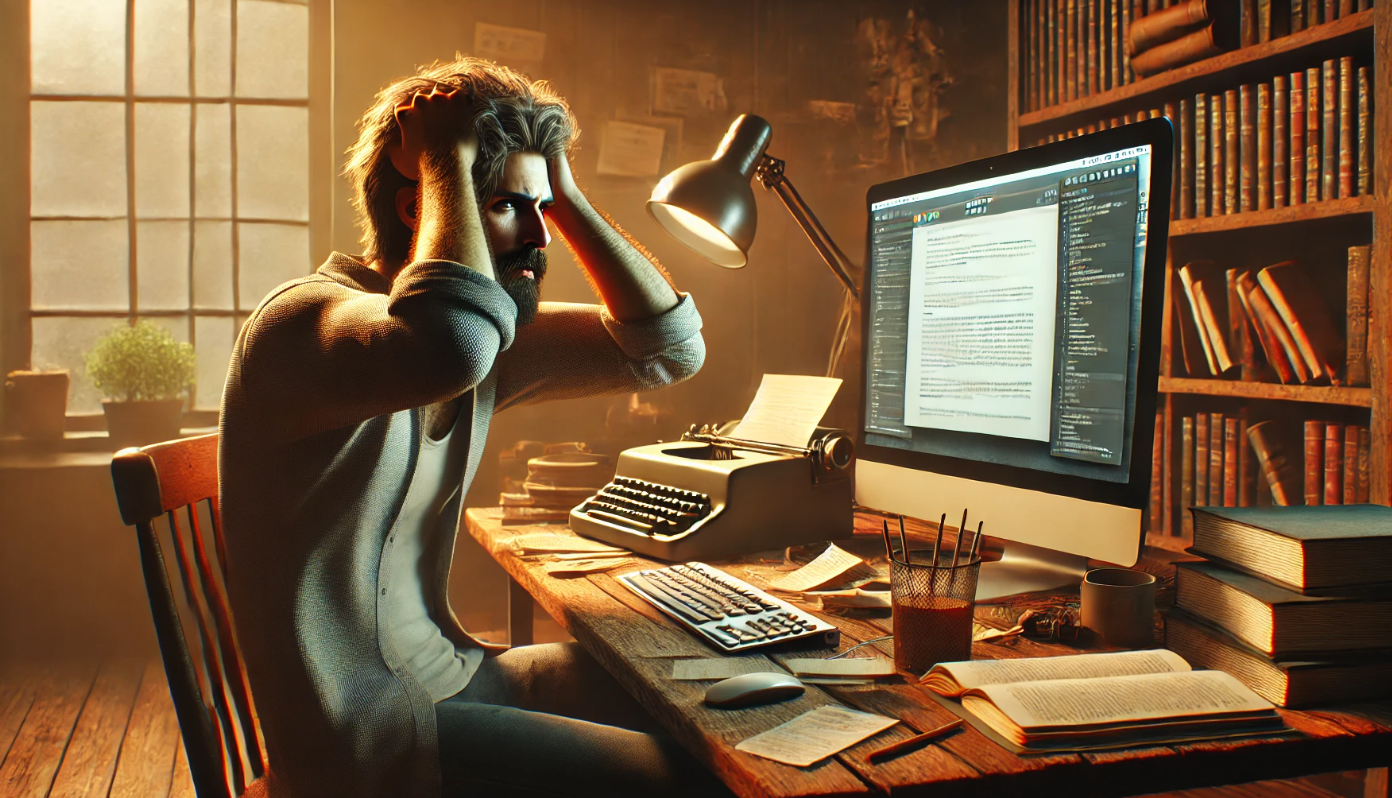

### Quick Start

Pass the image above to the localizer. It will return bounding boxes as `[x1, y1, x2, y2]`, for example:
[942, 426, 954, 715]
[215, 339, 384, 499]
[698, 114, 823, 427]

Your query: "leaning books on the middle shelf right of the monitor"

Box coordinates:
[1173, 245, 1371, 386]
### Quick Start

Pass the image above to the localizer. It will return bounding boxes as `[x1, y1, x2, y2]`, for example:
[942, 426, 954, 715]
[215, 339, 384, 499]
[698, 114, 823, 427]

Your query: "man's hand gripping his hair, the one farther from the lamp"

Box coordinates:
[387, 86, 479, 180]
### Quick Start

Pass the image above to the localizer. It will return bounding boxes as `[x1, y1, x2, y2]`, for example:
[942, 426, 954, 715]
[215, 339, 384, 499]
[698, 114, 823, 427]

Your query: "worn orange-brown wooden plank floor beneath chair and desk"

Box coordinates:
[0, 654, 1363, 798]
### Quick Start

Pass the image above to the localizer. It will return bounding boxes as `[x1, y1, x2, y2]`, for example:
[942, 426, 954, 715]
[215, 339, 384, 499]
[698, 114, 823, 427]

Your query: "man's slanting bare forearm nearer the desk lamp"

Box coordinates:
[550, 189, 679, 322]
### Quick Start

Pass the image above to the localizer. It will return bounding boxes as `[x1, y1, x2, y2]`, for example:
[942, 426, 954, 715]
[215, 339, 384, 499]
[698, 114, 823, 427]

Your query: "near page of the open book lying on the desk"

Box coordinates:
[974, 670, 1272, 731]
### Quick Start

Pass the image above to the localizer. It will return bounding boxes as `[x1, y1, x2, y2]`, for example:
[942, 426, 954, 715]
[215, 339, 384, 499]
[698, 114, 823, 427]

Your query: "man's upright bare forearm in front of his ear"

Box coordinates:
[412, 149, 494, 279]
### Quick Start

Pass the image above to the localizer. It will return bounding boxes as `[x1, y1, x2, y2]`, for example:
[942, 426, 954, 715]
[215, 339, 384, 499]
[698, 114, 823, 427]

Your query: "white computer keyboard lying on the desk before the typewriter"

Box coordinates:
[618, 563, 841, 652]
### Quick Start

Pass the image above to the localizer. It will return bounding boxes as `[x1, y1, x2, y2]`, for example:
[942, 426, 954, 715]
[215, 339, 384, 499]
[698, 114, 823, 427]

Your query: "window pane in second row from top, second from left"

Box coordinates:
[135, 103, 189, 217]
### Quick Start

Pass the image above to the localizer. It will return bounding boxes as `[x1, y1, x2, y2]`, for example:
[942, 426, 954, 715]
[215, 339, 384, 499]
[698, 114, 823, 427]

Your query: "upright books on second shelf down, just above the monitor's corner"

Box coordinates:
[1040, 56, 1374, 219]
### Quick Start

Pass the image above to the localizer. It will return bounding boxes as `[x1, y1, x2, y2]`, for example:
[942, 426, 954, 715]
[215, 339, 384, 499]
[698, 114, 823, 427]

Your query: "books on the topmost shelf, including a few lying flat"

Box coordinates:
[1020, 0, 1373, 111]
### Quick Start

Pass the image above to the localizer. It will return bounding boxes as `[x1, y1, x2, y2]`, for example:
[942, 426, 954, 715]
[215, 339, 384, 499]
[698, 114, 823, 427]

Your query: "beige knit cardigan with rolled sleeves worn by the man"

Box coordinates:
[219, 253, 704, 798]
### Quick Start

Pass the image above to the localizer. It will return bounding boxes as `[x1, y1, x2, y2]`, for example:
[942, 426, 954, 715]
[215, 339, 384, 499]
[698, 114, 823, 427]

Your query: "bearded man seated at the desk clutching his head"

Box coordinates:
[220, 58, 724, 798]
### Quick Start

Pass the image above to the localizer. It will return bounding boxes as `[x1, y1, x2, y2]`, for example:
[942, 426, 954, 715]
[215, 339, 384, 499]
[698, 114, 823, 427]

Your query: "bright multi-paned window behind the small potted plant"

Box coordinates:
[28, 0, 312, 414]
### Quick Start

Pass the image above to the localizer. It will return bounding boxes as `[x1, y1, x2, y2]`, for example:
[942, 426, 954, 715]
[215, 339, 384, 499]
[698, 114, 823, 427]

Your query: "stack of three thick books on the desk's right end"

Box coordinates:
[1165, 504, 1392, 707]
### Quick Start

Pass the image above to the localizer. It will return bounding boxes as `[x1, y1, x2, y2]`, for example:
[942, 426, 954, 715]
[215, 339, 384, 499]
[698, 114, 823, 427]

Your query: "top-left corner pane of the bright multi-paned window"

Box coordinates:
[29, 0, 125, 95]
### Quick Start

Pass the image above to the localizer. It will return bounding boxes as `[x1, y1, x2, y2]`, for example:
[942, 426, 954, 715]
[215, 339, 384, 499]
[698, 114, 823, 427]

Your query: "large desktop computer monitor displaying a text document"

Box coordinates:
[856, 118, 1173, 600]
